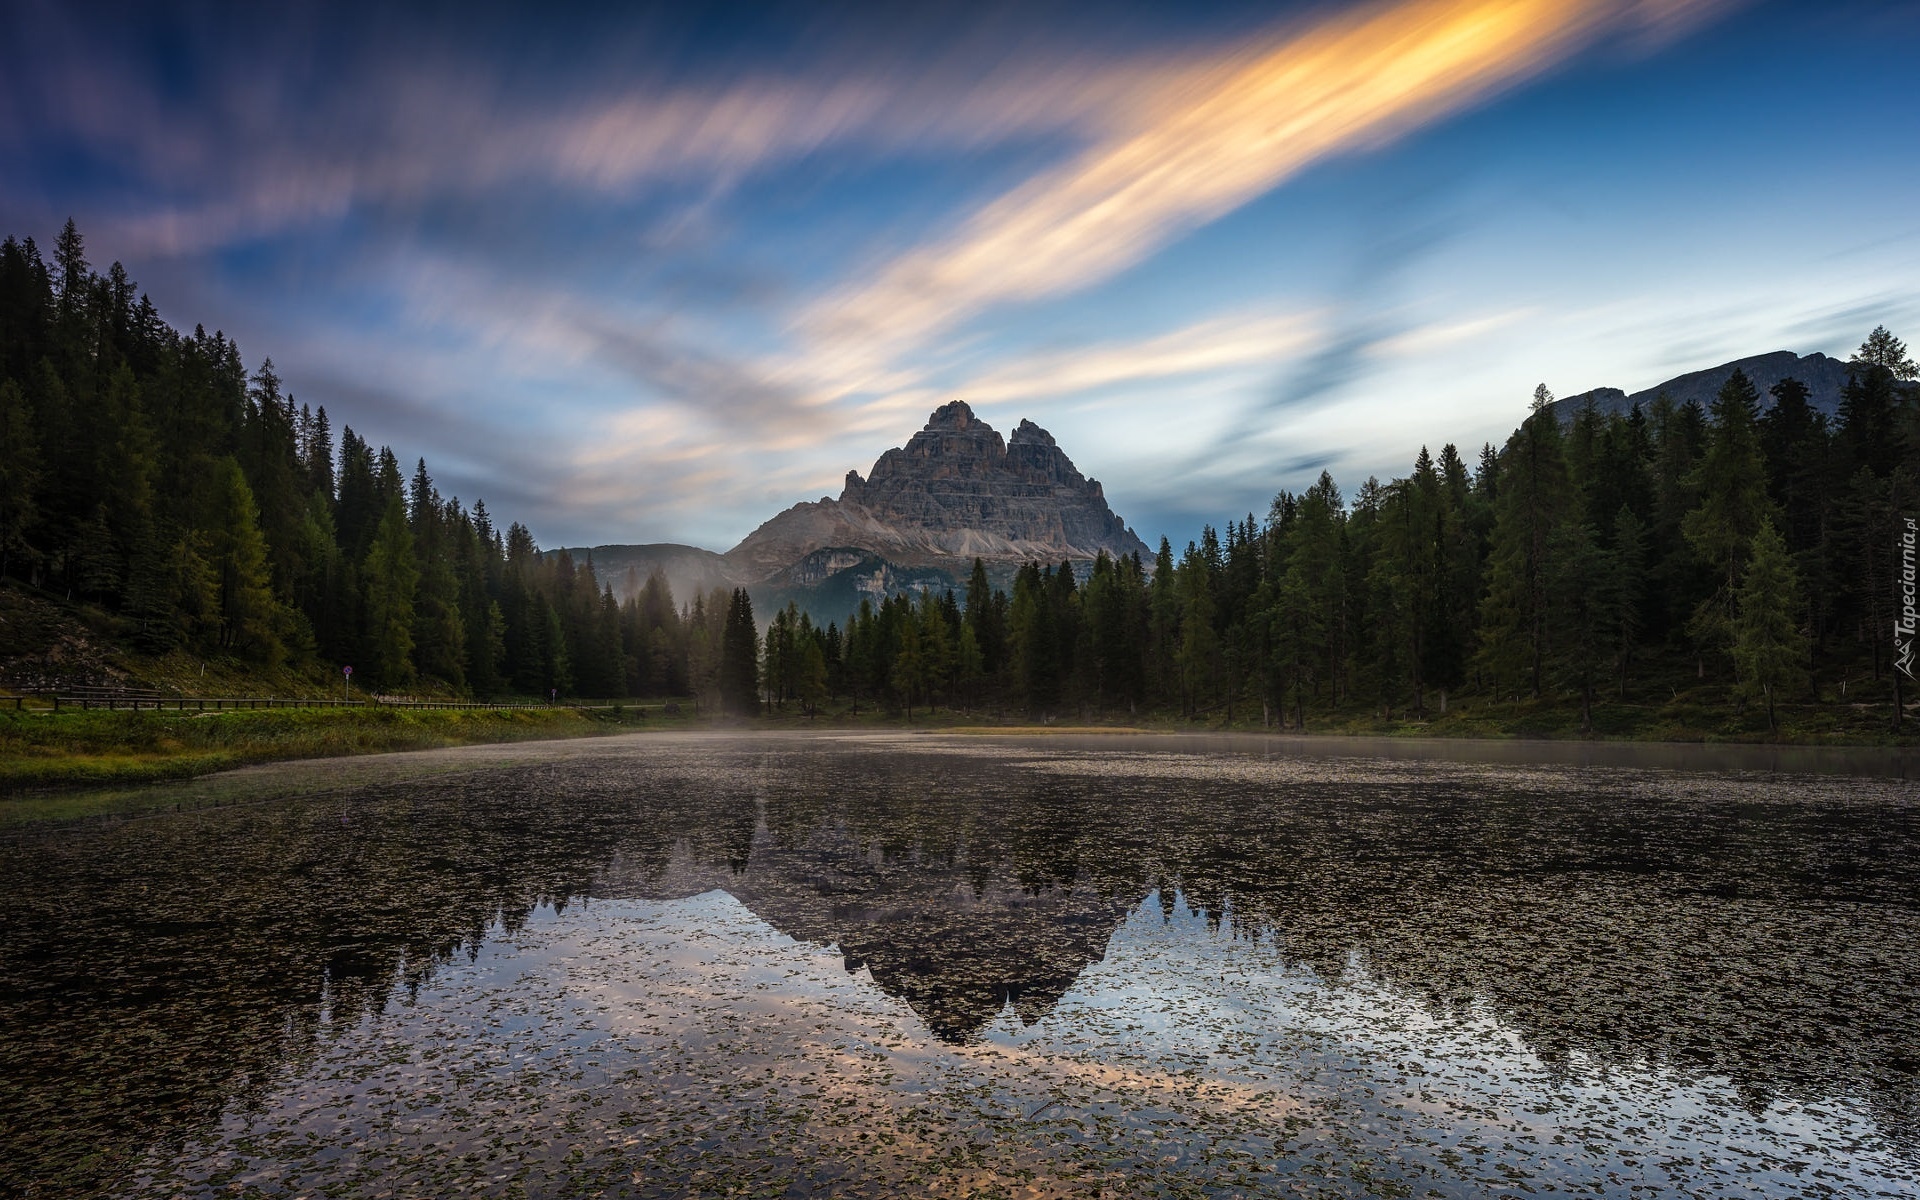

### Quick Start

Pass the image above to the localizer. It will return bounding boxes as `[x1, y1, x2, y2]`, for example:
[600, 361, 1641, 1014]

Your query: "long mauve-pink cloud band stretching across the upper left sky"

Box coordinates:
[0, 14, 1188, 255]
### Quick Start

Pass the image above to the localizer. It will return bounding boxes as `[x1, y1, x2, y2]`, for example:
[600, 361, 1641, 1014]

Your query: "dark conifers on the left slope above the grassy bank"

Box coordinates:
[0, 221, 724, 697]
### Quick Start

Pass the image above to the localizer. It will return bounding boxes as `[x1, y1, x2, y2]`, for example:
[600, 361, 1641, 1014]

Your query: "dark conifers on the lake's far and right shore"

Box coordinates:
[741, 328, 1920, 730]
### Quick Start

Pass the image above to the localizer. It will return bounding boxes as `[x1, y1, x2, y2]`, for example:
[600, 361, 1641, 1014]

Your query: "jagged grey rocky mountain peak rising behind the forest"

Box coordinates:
[726, 401, 1152, 578]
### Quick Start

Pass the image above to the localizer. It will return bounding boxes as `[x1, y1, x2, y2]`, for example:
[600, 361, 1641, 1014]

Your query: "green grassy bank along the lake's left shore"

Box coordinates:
[0, 705, 680, 795]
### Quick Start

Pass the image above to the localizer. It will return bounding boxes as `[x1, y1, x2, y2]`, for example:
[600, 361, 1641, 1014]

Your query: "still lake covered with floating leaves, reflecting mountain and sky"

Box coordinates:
[0, 735, 1920, 1198]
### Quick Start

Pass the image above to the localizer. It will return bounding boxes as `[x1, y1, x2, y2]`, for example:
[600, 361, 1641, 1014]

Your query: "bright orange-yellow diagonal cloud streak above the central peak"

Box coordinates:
[799, 0, 1720, 390]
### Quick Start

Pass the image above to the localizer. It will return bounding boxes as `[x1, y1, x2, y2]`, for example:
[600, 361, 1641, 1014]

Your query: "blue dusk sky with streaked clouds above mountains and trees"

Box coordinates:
[0, 0, 1920, 549]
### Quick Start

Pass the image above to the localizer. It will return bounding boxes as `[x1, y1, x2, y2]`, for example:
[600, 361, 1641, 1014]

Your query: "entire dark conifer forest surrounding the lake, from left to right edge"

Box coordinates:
[0, 223, 1920, 730]
